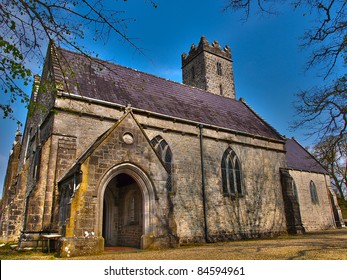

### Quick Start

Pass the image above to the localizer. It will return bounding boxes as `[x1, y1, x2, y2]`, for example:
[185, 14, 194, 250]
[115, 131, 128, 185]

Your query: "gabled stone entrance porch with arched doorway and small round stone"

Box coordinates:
[59, 111, 175, 255]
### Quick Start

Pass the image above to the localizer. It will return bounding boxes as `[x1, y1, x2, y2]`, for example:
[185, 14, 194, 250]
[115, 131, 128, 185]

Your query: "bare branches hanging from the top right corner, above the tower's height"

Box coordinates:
[224, 0, 347, 74]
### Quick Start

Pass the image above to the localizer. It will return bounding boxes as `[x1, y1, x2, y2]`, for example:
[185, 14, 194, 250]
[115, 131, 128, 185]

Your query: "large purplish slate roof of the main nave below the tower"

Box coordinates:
[53, 48, 283, 140]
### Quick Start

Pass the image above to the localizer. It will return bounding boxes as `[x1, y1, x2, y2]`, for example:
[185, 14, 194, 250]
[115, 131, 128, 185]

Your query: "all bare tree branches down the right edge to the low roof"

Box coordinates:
[225, 0, 347, 197]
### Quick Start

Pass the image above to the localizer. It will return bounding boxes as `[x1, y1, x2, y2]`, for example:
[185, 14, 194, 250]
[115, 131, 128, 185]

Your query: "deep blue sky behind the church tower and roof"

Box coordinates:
[0, 0, 342, 197]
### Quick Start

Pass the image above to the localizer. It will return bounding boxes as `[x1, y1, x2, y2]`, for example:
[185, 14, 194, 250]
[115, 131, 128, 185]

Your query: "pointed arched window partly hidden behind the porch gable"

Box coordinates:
[151, 135, 173, 192]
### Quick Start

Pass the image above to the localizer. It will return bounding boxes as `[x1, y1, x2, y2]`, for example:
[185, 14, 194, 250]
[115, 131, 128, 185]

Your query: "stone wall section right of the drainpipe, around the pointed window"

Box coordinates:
[205, 137, 286, 240]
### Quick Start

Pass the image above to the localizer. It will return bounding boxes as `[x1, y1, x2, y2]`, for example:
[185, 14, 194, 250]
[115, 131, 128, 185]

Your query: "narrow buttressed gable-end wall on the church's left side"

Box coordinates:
[19, 44, 60, 246]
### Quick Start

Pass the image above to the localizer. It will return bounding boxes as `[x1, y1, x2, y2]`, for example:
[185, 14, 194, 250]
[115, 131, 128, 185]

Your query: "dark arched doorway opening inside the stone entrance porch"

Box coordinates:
[102, 173, 143, 248]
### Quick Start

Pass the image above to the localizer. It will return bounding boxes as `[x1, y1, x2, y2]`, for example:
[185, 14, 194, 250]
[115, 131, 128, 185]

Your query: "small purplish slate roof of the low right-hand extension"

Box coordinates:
[285, 139, 328, 174]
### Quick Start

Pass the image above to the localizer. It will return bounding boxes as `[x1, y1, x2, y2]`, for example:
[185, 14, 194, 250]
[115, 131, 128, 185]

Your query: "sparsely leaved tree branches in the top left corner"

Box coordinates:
[0, 0, 157, 122]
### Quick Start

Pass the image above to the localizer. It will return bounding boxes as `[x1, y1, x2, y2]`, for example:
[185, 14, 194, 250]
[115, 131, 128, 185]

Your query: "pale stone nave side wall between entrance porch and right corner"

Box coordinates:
[143, 117, 286, 243]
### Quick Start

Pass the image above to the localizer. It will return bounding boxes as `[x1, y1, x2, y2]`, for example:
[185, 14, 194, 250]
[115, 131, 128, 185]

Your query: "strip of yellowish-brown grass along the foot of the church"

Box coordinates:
[0, 228, 347, 260]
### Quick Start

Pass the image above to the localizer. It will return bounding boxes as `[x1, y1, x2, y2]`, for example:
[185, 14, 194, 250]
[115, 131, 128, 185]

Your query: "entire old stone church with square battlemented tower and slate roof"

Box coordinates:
[1, 37, 341, 257]
